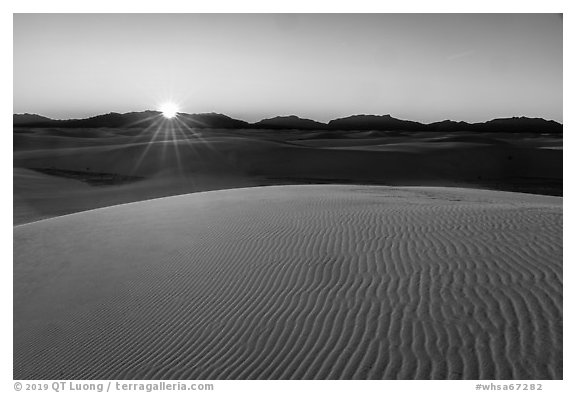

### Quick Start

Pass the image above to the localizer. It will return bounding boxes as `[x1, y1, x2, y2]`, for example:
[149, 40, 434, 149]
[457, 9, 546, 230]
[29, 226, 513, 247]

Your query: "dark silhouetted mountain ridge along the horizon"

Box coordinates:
[13, 111, 563, 134]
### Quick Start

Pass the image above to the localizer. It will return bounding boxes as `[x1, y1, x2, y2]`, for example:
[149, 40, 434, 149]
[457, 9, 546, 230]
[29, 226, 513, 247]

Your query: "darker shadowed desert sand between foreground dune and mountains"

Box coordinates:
[13, 127, 562, 225]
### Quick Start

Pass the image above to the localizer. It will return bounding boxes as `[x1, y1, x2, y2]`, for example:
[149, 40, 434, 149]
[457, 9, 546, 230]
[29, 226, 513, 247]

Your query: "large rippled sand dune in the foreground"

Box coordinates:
[14, 186, 562, 379]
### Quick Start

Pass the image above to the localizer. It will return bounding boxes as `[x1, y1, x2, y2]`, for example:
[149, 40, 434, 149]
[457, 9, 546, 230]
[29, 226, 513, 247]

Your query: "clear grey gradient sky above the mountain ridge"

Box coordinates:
[13, 14, 562, 123]
